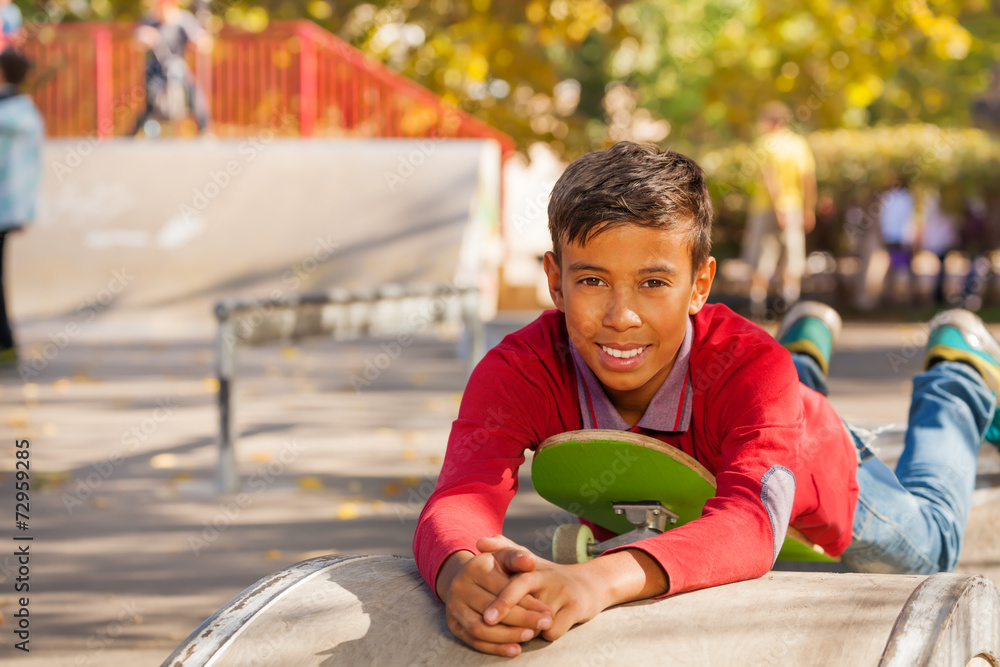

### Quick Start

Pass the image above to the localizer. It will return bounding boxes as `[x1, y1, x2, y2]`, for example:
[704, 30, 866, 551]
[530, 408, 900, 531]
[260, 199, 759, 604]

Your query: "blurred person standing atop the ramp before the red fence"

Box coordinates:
[129, 0, 212, 136]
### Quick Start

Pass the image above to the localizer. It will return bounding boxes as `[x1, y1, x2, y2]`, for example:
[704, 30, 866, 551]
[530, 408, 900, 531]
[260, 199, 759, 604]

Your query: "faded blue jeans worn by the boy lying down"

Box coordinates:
[792, 354, 996, 574]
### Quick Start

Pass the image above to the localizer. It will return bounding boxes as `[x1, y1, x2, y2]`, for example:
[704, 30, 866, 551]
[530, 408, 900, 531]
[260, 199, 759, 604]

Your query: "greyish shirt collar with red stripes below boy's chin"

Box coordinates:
[569, 317, 694, 432]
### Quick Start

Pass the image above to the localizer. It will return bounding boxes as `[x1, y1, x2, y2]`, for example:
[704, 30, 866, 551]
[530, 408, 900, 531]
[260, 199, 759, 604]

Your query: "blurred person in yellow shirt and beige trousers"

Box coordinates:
[743, 102, 816, 318]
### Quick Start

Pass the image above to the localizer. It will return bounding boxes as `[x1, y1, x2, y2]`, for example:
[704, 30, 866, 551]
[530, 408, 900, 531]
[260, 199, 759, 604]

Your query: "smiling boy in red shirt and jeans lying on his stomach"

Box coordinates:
[413, 142, 1000, 656]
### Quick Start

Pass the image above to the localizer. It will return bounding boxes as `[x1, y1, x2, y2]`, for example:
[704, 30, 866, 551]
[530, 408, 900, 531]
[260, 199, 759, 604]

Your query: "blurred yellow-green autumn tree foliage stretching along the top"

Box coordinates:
[16, 0, 1000, 157]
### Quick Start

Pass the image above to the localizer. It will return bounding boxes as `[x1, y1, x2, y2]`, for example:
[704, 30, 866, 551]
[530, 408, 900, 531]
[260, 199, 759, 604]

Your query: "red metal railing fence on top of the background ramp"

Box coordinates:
[25, 21, 514, 155]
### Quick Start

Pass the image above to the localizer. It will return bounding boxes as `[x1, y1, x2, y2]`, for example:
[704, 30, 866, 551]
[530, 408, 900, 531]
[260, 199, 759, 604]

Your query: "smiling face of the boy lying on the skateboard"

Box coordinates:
[545, 225, 715, 423]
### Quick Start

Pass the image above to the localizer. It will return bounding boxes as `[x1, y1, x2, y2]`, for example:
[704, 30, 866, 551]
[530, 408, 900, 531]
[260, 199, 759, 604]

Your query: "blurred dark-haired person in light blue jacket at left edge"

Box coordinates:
[0, 47, 44, 365]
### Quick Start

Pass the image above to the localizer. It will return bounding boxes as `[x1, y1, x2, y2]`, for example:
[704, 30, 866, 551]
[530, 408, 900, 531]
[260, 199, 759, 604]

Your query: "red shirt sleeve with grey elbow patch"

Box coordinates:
[600, 347, 803, 595]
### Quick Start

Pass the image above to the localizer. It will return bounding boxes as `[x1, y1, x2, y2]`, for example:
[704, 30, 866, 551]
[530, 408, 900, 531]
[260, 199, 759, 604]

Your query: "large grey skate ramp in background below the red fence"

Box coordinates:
[8, 138, 500, 332]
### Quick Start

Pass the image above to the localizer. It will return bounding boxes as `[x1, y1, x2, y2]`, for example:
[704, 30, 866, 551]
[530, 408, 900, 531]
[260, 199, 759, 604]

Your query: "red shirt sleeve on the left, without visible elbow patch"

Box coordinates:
[413, 349, 552, 590]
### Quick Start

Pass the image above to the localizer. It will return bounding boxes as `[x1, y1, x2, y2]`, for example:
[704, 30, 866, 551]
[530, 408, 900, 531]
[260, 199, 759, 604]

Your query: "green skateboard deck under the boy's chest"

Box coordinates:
[531, 429, 834, 562]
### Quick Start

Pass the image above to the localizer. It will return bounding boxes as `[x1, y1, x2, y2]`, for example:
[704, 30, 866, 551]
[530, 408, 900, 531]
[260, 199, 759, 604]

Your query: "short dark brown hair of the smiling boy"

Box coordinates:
[549, 141, 712, 272]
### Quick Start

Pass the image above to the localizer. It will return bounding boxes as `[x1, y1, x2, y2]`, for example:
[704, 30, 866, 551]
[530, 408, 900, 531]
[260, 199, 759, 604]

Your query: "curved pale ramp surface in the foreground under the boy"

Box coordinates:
[163, 556, 1000, 667]
